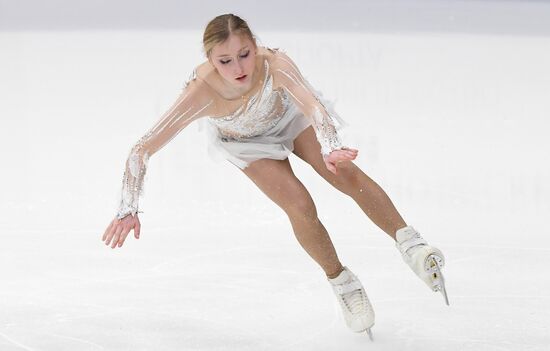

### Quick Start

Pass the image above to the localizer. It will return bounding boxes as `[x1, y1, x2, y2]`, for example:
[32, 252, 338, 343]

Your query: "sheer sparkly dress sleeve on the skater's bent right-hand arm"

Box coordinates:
[271, 50, 343, 156]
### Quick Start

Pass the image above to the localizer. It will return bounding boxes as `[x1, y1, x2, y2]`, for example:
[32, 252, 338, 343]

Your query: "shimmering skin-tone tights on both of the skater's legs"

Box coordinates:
[243, 127, 407, 278]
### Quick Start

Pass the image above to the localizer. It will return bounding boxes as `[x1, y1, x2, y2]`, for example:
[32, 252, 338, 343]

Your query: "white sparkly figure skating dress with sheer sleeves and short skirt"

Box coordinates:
[117, 47, 343, 218]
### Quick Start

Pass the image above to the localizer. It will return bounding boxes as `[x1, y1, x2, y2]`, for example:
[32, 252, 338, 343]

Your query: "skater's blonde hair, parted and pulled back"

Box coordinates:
[202, 13, 256, 58]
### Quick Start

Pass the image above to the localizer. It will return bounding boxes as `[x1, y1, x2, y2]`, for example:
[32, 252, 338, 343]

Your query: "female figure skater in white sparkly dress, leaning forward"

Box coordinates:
[102, 14, 448, 337]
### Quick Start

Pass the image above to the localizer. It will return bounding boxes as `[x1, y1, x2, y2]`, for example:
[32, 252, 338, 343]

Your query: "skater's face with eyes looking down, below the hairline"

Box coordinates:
[208, 34, 256, 92]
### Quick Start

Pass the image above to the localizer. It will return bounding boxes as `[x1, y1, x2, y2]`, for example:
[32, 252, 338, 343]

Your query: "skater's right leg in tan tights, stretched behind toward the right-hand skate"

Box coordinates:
[294, 127, 407, 240]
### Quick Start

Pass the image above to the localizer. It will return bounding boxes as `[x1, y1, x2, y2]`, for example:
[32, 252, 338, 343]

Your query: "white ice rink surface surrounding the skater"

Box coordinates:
[0, 1, 550, 351]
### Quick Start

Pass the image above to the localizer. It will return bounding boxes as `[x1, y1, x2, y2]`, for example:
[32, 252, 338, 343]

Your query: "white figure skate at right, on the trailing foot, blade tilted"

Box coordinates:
[395, 226, 449, 305]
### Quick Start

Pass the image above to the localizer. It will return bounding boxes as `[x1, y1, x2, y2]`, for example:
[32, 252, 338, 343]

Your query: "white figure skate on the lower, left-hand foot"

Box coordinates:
[329, 267, 374, 340]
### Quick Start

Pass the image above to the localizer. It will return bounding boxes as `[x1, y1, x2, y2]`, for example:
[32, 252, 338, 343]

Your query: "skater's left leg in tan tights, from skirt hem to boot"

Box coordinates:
[243, 159, 343, 278]
